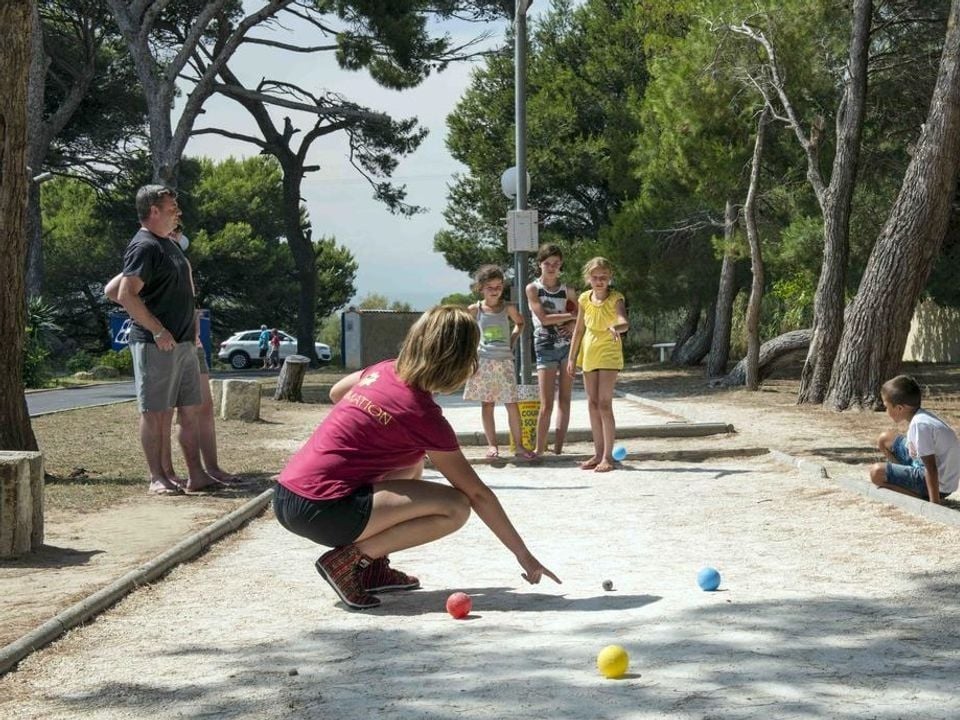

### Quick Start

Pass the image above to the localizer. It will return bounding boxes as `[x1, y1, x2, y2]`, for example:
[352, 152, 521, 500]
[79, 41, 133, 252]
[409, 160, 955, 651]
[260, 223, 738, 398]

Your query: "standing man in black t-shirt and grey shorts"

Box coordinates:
[117, 185, 221, 495]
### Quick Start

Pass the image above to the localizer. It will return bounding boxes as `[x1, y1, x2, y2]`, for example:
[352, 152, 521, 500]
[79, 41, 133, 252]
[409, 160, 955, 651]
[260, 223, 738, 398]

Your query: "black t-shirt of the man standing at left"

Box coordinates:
[123, 228, 196, 343]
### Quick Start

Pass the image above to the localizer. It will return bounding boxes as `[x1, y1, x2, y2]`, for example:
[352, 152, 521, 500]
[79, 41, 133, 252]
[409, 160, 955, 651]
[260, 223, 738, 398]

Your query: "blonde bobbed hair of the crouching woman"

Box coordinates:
[396, 305, 480, 393]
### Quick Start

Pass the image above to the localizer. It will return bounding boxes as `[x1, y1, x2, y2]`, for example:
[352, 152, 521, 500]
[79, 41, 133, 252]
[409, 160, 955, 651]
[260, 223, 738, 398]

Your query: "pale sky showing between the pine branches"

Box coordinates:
[175, 3, 547, 309]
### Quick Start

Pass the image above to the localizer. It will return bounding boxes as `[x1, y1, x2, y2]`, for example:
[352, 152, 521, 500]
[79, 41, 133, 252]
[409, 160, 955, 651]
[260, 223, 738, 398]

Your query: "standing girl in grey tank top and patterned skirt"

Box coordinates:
[463, 265, 537, 460]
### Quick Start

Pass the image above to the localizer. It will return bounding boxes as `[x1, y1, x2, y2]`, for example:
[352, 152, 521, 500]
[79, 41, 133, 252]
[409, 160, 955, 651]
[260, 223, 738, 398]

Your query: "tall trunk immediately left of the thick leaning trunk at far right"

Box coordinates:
[797, 0, 873, 403]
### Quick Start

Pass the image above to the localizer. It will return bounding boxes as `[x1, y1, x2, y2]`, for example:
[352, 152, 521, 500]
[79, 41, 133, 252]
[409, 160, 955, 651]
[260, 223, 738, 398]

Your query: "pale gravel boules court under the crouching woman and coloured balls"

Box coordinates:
[0, 450, 960, 719]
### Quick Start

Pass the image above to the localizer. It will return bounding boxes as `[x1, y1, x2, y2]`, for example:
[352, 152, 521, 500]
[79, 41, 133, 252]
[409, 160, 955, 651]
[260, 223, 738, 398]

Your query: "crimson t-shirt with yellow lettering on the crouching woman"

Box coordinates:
[279, 360, 460, 500]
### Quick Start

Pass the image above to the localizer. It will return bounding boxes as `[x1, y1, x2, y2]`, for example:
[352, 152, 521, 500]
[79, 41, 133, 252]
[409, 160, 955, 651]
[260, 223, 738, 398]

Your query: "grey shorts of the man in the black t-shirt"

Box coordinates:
[130, 342, 202, 412]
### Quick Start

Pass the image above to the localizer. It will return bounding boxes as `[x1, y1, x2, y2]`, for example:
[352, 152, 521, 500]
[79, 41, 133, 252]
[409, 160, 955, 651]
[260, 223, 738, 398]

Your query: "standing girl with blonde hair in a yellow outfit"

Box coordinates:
[567, 257, 629, 472]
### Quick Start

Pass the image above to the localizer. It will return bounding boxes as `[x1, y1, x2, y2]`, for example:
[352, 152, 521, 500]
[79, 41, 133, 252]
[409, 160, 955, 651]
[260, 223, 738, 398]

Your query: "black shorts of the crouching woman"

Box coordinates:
[273, 485, 373, 547]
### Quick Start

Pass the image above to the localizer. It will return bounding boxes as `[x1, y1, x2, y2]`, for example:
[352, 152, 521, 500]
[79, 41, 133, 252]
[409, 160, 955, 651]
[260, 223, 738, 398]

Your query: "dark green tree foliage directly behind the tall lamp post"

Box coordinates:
[434, 0, 647, 273]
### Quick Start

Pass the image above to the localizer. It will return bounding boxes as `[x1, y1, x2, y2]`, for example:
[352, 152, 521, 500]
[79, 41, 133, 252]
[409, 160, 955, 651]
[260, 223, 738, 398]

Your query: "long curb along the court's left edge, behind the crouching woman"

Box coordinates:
[0, 488, 273, 676]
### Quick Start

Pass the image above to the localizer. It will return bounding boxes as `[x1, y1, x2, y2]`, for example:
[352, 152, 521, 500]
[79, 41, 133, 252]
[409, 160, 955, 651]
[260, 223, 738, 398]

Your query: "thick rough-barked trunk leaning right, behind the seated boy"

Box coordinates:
[826, 0, 960, 410]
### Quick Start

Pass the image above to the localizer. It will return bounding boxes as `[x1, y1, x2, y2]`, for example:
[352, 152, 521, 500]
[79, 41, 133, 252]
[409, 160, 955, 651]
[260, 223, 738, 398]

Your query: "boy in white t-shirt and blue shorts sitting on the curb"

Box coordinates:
[870, 375, 960, 505]
